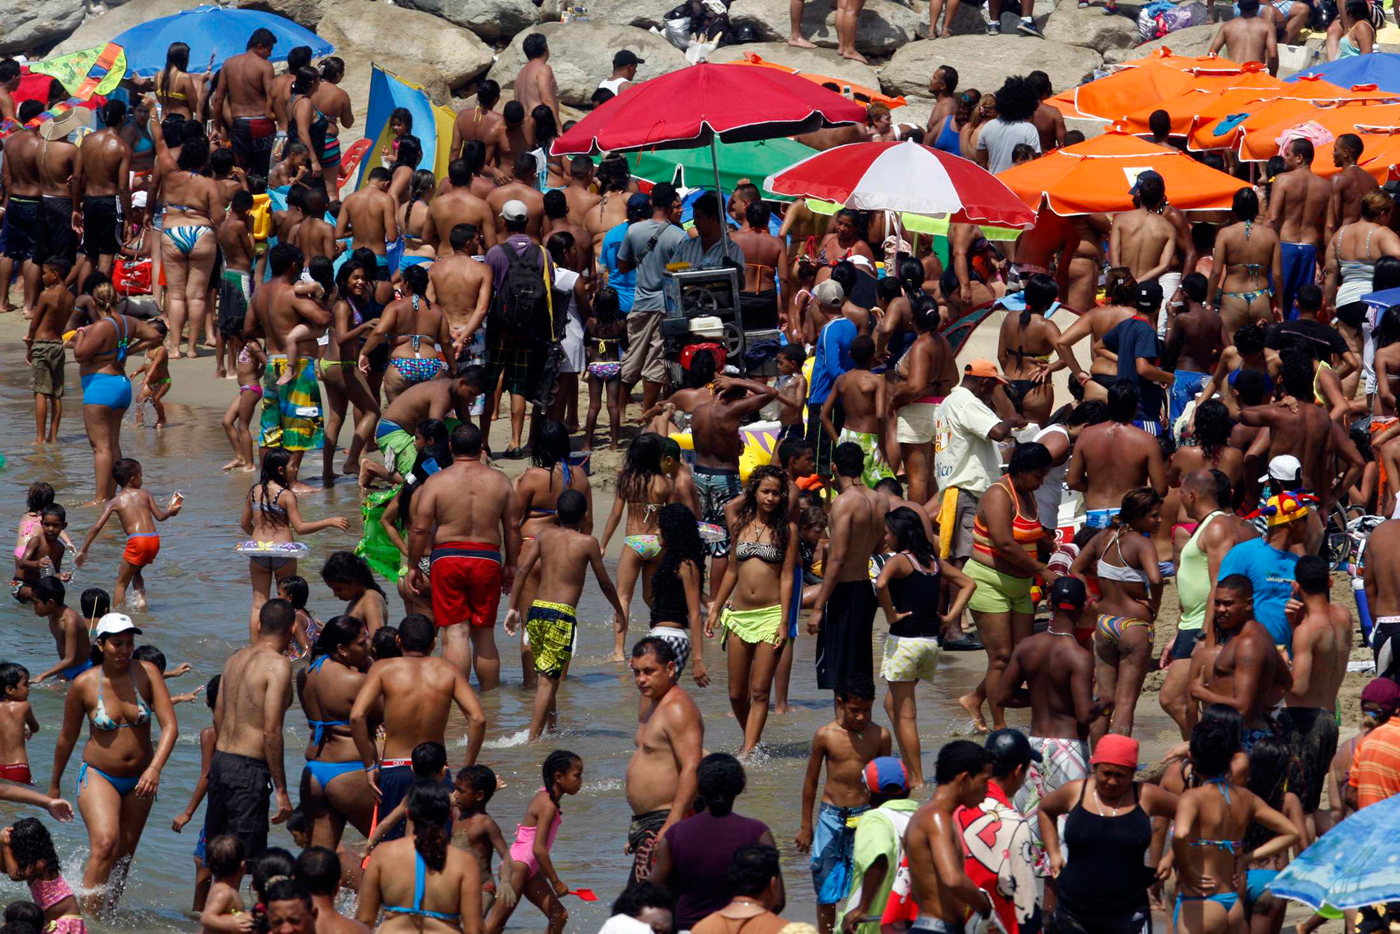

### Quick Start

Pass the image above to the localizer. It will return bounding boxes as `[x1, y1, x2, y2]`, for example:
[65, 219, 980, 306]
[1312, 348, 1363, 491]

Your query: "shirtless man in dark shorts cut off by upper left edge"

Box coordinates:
[0, 100, 45, 318]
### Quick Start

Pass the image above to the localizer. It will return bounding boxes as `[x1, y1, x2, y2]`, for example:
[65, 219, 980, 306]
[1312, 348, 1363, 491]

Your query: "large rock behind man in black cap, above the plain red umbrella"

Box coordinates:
[489, 22, 689, 106]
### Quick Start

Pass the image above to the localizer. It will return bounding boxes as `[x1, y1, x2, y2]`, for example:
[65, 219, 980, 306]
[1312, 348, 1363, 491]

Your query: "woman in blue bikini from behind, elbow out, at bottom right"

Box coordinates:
[1172, 721, 1298, 934]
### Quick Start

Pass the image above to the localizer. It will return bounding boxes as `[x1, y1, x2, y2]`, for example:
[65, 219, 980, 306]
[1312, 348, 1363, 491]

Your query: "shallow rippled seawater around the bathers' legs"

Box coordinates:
[0, 343, 1187, 931]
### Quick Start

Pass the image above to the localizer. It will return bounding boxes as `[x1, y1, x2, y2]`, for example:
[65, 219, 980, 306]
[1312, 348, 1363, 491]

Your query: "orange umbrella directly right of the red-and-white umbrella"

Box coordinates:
[997, 126, 1247, 216]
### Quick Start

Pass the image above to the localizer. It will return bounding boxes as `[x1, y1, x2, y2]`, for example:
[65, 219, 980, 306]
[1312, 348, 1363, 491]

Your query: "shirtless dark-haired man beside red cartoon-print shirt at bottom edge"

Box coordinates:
[904, 739, 993, 934]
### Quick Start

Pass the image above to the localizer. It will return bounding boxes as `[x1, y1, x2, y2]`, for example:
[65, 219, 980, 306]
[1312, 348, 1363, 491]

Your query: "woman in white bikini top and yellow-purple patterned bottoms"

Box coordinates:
[1070, 487, 1162, 742]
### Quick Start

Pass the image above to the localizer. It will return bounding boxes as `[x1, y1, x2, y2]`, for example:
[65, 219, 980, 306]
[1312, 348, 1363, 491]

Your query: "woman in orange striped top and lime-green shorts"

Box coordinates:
[958, 442, 1058, 732]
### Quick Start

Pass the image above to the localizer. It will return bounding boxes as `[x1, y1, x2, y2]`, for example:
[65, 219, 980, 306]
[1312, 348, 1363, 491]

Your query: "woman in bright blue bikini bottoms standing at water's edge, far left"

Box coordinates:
[73, 283, 161, 506]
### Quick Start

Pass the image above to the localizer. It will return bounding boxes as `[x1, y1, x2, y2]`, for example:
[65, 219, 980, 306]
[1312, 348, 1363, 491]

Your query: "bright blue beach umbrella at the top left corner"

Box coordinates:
[112, 7, 335, 78]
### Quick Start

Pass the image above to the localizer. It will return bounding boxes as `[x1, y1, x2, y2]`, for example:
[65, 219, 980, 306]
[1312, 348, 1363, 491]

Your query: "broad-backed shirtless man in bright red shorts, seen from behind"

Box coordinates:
[408, 422, 521, 686]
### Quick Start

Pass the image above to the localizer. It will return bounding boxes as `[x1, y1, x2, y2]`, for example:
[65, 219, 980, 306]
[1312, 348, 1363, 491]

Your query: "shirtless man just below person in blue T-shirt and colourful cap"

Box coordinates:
[1191, 574, 1294, 752]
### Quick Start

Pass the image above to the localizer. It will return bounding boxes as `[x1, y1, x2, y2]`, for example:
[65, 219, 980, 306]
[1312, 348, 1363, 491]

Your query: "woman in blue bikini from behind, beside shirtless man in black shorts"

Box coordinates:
[298, 616, 374, 850]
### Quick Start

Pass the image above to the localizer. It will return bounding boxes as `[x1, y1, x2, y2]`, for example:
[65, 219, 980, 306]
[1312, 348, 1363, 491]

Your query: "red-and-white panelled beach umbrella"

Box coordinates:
[763, 140, 1036, 228]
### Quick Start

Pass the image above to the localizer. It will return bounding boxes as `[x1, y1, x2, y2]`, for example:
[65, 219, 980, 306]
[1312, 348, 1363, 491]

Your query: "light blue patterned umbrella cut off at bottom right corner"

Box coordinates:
[1268, 797, 1400, 910]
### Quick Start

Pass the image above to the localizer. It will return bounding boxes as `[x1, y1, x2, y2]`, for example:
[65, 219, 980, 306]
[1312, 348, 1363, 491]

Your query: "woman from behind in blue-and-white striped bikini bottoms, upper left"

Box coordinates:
[155, 134, 224, 360]
